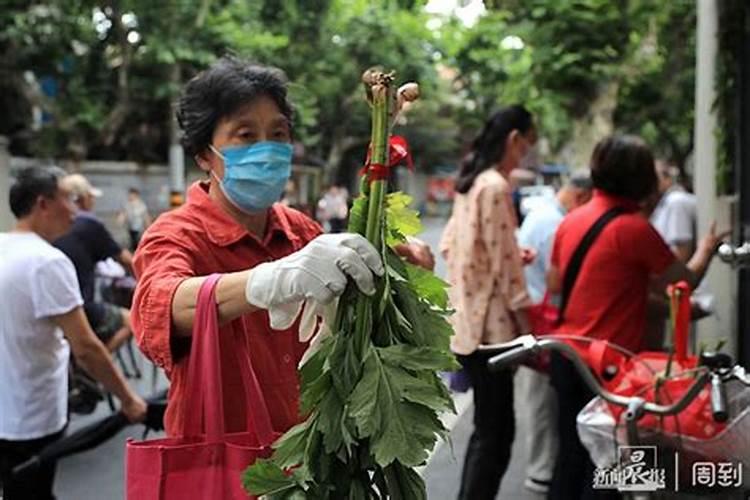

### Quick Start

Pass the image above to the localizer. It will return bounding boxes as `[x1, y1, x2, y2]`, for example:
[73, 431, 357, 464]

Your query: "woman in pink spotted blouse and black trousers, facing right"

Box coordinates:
[440, 106, 536, 500]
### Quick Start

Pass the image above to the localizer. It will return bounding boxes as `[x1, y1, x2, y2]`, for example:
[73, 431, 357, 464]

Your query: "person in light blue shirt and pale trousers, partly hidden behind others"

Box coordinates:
[515, 170, 592, 493]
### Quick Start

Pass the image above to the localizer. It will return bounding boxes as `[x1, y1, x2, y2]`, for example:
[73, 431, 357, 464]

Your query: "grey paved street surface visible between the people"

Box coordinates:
[55, 219, 542, 500]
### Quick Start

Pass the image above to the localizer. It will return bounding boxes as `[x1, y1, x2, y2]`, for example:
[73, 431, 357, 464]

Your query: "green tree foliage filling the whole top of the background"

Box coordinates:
[0, 0, 695, 180]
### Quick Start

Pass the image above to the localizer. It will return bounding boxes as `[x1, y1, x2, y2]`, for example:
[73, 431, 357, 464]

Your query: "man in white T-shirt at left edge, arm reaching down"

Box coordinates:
[0, 167, 146, 500]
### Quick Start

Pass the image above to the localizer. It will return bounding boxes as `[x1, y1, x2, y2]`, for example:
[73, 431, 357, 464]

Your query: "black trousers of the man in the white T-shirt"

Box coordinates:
[0, 429, 65, 500]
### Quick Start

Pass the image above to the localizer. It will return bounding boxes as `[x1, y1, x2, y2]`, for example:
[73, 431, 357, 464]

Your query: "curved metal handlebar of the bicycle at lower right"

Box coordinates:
[483, 335, 712, 421]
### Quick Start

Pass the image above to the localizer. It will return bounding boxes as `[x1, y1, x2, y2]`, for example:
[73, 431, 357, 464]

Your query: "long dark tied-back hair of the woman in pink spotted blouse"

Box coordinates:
[456, 104, 534, 193]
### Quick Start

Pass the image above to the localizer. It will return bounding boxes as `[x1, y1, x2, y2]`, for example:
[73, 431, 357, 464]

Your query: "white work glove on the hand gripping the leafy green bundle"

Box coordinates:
[245, 233, 385, 330]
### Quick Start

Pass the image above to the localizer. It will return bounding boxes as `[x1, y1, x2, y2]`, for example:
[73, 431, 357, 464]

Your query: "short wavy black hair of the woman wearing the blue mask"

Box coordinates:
[177, 56, 294, 156]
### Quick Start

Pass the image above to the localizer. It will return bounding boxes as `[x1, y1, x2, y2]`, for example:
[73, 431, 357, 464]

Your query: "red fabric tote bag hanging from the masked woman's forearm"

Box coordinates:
[126, 274, 277, 500]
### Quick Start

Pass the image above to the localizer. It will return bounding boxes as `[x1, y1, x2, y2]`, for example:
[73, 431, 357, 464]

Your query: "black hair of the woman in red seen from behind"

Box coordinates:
[591, 135, 658, 202]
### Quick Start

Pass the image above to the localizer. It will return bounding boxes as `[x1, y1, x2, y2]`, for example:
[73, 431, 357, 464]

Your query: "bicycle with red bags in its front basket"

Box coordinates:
[481, 335, 750, 498]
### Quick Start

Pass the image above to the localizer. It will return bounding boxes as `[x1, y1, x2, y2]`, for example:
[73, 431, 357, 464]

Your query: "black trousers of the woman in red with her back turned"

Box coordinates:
[547, 353, 621, 500]
